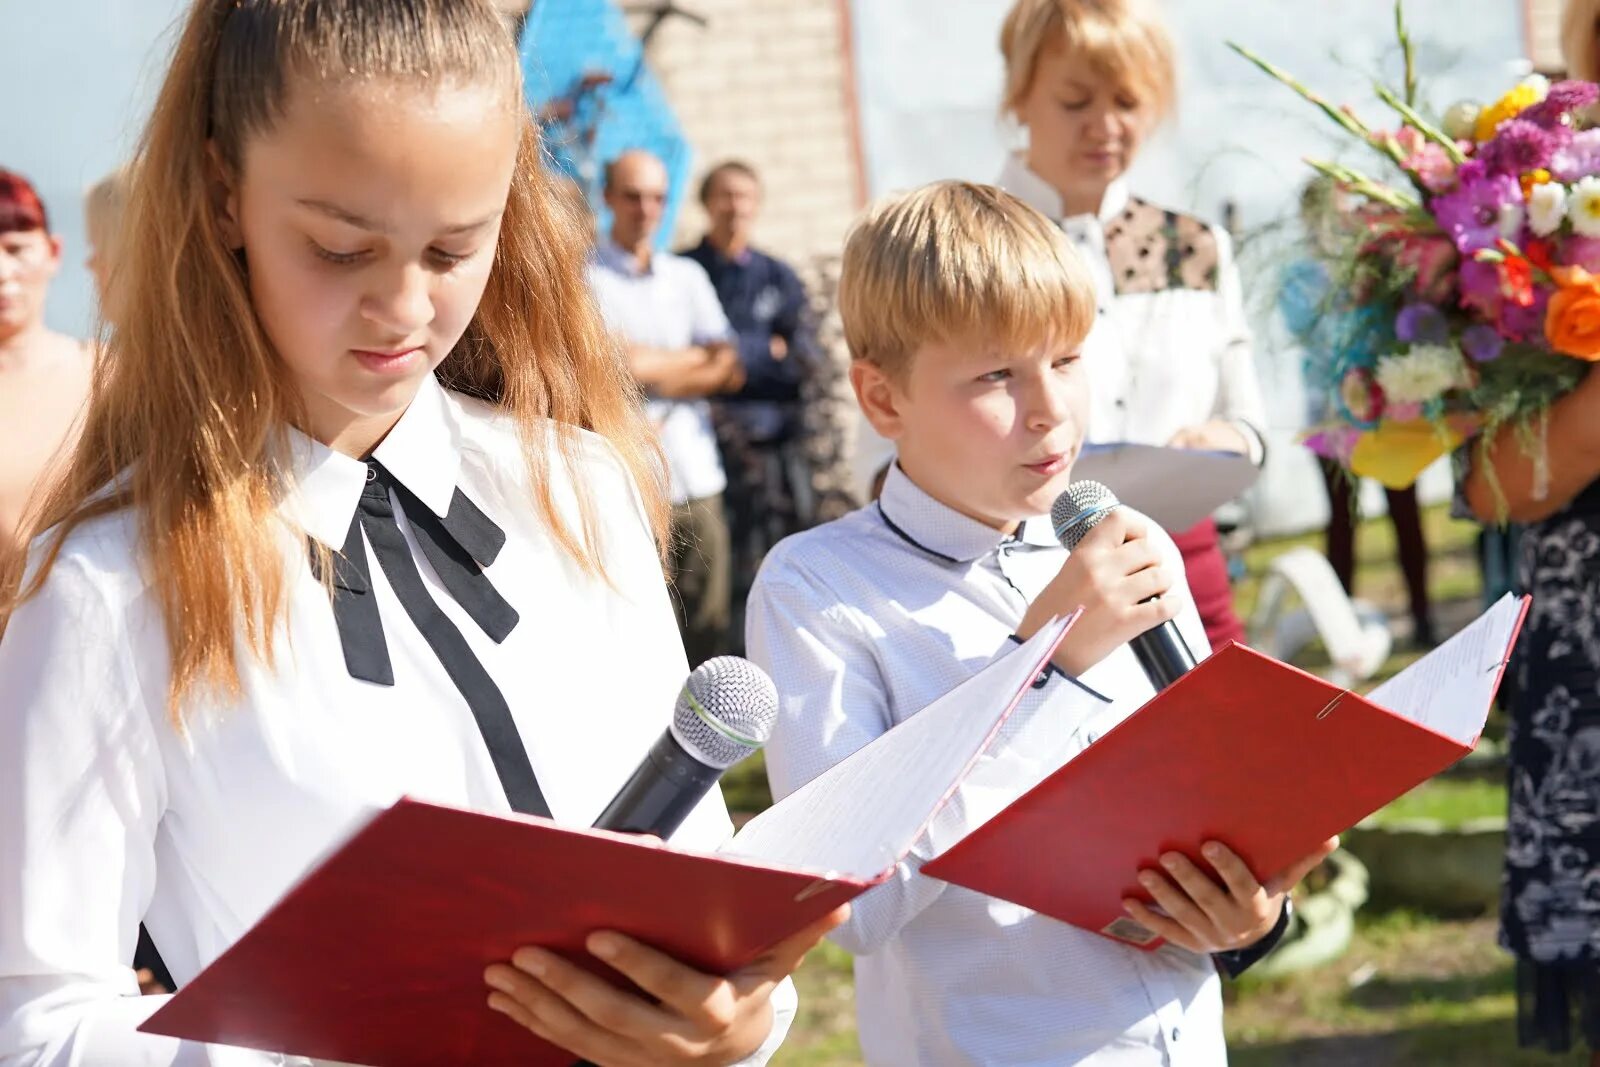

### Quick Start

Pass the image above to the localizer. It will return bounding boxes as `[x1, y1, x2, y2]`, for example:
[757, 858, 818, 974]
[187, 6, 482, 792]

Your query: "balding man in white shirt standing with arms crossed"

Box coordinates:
[589, 149, 744, 664]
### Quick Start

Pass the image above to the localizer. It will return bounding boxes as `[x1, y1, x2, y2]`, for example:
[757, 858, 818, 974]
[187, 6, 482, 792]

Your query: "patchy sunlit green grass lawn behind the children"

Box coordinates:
[761, 507, 1548, 1067]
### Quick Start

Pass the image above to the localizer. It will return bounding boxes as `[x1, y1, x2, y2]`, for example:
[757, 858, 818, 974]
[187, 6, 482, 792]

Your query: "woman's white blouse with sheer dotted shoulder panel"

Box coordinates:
[995, 154, 1266, 464]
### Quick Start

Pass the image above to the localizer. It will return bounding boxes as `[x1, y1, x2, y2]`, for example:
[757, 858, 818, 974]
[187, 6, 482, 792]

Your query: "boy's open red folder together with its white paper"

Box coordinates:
[922, 598, 1528, 949]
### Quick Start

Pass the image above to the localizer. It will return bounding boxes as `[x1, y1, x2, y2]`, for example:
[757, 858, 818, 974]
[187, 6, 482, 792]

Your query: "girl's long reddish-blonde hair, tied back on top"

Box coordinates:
[0, 0, 666, 723]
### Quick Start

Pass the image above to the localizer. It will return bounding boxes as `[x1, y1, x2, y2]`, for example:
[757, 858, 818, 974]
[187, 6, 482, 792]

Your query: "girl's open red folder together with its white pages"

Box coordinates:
[141, 619, 1070, 1067]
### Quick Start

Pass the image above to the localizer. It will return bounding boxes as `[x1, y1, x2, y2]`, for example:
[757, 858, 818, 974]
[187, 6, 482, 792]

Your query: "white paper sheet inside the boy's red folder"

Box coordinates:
[1366, 593, 1522, 745]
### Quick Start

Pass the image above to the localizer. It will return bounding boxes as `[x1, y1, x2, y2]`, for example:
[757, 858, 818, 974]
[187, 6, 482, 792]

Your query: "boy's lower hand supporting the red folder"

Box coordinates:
[1122, 837, 1339, 953]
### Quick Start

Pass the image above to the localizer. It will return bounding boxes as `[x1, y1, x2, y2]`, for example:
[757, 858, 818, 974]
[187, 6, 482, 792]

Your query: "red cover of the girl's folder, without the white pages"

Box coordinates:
[142, 800, 869, 1067]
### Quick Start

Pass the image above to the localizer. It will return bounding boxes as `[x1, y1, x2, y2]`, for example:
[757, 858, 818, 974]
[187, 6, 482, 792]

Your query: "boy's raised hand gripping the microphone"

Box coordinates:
[1016, 507, 1182, 677]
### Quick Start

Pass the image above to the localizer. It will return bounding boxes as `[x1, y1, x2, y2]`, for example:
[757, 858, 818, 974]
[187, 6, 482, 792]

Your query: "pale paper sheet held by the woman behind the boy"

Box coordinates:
[1072, 445, 1259, 530]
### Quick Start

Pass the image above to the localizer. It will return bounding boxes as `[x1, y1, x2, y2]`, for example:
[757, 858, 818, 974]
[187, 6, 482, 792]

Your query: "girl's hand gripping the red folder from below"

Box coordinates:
[483, 905, 850, 1067]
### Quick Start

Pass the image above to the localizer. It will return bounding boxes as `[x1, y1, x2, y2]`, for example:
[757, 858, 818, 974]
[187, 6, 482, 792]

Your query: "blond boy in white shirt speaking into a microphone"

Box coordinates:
[747, 182, 1331, 1067]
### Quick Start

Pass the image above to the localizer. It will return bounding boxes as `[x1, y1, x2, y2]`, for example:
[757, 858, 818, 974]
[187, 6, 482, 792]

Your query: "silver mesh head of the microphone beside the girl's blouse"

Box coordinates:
[672, 656, 778, 769]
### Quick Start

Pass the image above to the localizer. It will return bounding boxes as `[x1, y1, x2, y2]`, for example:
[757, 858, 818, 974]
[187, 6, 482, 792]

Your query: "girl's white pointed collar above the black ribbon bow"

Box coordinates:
[288, 374, 461, 547]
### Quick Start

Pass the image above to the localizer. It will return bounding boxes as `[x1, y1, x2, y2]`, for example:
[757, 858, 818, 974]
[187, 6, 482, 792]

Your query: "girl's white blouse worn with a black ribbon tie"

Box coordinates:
[0, 378, 795, 1067]
